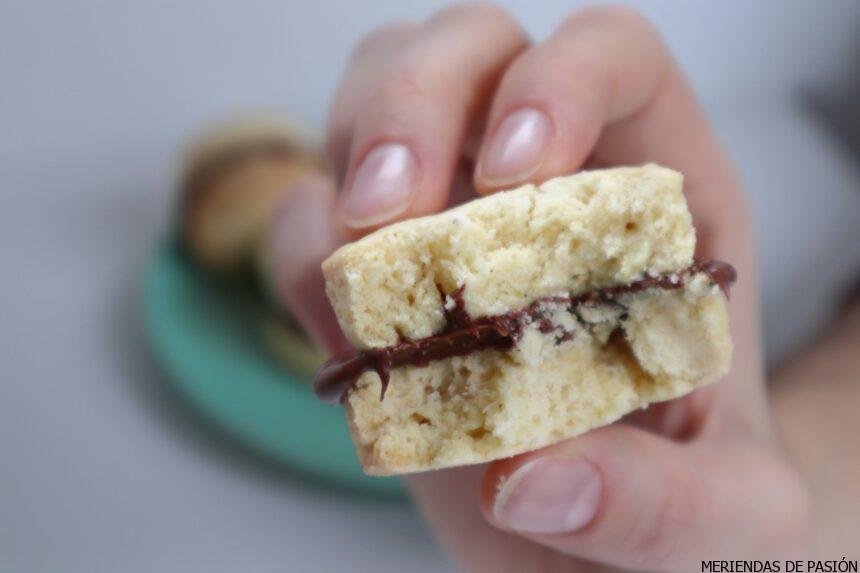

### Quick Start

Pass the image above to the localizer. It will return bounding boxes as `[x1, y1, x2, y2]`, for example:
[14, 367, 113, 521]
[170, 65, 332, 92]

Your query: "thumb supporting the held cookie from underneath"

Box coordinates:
[482, 425, 808, 571]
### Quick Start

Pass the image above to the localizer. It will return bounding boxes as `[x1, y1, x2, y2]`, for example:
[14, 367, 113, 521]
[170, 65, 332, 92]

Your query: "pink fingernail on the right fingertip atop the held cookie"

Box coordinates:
[478, 108, 552, 186]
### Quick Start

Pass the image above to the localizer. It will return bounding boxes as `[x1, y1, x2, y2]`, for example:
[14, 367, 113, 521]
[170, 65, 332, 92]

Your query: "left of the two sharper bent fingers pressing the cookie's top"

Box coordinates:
[328, 4, 525, 236]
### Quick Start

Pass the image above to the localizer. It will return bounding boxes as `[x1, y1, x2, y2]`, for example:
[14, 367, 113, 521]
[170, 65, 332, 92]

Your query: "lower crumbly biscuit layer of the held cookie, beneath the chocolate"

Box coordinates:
[344, 280, 731, 475]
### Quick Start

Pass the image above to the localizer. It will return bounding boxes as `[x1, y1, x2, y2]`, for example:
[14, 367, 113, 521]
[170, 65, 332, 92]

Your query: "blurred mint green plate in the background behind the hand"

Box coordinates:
[143, 243, 403, 497]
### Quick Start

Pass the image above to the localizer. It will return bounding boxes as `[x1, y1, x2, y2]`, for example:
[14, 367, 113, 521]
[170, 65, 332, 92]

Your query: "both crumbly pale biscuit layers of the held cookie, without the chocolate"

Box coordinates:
[323, 165, 731, 475]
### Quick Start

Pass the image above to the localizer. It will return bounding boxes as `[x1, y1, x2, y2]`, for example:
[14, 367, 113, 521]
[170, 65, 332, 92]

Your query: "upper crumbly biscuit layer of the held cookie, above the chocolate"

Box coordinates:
[323, 165, 696, 349]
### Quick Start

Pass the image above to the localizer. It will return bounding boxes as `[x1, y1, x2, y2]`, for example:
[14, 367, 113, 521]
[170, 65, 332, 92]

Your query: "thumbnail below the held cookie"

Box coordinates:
[493, 457, 603, 534]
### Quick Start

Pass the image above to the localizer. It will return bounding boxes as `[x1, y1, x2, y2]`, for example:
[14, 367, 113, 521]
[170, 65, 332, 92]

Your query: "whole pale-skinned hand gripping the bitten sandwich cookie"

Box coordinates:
[271, 4, 860, 572]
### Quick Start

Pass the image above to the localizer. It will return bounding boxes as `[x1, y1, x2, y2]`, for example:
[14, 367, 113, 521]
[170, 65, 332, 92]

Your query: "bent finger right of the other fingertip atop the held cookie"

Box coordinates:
[475, 7, 736, 242]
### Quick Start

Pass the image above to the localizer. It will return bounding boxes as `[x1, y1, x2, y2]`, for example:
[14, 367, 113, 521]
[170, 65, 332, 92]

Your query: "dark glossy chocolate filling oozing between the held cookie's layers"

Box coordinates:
[314, 259, 737, 403]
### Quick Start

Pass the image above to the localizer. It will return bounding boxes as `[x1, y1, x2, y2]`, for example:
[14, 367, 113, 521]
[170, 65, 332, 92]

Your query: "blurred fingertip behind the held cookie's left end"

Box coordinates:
[269, 175, 350, 353]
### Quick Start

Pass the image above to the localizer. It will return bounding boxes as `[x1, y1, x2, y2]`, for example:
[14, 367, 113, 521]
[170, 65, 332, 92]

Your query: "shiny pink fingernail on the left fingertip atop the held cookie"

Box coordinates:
[343, 143, 418, 229]
